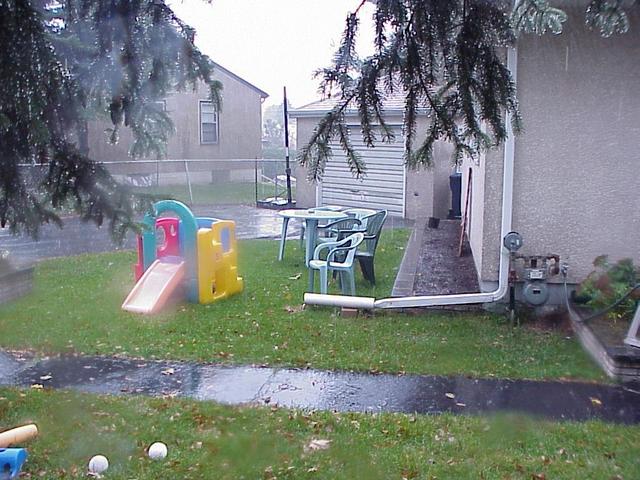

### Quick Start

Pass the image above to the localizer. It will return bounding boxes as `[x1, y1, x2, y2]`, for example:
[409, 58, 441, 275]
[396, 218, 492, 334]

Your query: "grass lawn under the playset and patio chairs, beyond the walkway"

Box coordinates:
[0, 230, 605, 381]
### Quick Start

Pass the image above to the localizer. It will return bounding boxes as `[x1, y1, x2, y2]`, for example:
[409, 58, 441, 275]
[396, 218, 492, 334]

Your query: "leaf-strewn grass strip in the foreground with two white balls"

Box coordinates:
[0, 389, 640, 480]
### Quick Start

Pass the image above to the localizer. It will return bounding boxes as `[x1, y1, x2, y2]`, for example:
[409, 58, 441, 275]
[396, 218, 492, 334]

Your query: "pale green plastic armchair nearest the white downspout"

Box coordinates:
[309, 232, 364, 295]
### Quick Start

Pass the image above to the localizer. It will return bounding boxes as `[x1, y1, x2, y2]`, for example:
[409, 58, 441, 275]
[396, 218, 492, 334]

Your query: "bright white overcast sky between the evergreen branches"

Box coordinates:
[171, 0, 373, 107]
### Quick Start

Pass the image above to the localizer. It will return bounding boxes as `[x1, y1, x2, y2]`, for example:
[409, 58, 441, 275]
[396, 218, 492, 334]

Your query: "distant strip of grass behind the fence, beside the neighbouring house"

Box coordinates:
[138, 182, 295, 205]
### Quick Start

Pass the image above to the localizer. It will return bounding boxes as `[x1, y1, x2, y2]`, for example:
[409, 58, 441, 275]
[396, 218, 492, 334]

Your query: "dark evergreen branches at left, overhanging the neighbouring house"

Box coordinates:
[0, 0, 221, 239]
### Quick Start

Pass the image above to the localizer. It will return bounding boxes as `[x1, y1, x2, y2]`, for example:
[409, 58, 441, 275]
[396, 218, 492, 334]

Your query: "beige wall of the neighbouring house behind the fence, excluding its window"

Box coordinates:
[89, 69, 262, 161]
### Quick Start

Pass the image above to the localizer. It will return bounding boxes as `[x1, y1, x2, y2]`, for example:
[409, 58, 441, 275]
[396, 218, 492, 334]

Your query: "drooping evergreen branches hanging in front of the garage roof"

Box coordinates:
[301, 0, 520, 179]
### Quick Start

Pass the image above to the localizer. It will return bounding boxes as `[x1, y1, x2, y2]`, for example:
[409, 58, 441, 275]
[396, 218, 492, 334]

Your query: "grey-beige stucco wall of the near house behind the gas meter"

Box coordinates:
[470, 11, 640, 282]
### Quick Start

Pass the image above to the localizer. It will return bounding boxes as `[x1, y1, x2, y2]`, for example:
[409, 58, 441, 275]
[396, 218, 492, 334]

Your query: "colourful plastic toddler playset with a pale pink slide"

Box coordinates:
[122, 200, 243, 314]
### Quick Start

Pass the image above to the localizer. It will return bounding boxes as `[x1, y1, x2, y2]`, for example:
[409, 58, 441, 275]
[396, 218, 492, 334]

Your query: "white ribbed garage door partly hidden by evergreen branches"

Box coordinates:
[319, 126, 406, 217]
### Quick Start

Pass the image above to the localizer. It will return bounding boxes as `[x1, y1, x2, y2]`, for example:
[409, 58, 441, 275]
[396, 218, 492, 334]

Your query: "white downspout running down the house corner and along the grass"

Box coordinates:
[304, 44, 518, 309]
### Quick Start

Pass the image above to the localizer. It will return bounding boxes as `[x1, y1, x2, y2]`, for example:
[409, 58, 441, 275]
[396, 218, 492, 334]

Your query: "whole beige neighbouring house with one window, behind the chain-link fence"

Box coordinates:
[89, 64, 268, 181]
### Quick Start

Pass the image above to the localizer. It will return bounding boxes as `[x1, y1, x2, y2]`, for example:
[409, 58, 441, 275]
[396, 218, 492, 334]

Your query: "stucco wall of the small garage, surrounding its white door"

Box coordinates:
[293, 116, 452, 219]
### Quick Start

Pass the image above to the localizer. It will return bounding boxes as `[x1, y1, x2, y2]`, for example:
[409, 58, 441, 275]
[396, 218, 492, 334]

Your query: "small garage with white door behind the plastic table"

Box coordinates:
[290, 95, 453, 219]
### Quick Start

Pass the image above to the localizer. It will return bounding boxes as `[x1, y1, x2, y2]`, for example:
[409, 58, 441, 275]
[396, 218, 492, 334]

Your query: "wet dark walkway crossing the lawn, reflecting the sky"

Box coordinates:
[0, 352, 640, 424]
